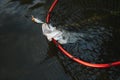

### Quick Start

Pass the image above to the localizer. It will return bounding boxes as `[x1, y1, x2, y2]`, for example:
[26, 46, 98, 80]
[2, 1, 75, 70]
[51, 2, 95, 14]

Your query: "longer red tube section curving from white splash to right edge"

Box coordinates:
[52, 39, 120, 68]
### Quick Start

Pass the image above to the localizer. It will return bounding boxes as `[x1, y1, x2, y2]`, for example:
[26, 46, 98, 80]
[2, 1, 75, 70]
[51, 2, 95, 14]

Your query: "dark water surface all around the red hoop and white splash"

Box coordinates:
[0, 0, 120, 80]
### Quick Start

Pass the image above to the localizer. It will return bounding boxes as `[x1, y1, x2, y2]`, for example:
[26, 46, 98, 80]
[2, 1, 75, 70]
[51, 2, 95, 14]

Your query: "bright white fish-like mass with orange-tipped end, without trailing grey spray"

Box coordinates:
[32, 16, 68, 44]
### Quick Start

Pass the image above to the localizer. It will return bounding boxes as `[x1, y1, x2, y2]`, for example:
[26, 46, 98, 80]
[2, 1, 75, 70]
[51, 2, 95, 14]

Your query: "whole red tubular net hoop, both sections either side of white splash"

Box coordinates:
[46, 0, 120, 68]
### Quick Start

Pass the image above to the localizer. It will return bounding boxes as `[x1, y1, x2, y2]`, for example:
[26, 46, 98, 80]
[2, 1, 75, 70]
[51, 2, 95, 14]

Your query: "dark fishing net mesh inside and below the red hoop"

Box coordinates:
[46, 0, 120, 80]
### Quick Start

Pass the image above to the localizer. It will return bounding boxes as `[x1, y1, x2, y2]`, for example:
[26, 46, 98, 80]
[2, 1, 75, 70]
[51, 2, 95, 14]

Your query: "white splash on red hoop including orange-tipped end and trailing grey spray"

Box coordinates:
[32, 16, 81, 44]
